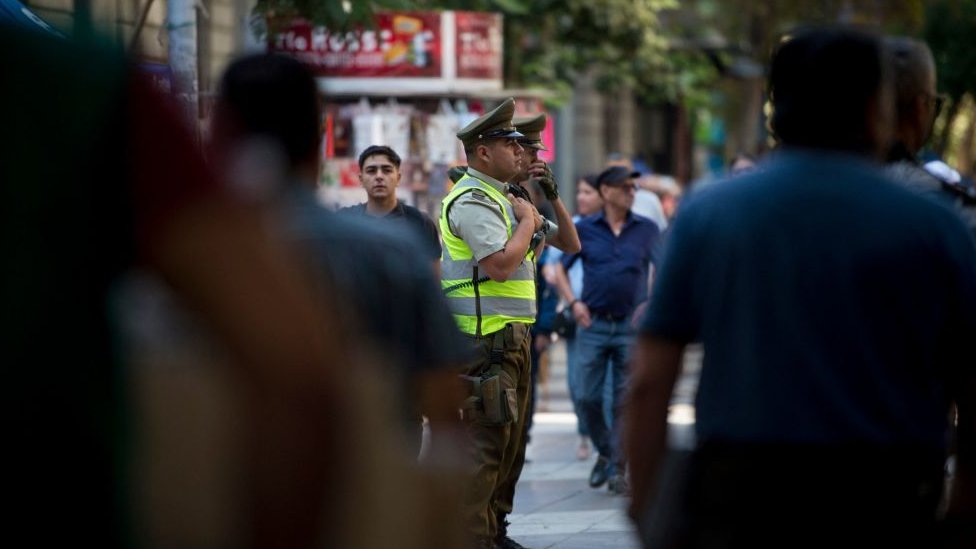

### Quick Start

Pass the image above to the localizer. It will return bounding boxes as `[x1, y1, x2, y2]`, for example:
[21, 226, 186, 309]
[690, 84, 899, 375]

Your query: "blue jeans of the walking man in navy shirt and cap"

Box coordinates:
[576, 318, 634, 475]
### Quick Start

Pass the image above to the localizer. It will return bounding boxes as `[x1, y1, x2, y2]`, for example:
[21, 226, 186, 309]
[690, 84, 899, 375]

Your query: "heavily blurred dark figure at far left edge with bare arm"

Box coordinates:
[0, 25, 351, 547]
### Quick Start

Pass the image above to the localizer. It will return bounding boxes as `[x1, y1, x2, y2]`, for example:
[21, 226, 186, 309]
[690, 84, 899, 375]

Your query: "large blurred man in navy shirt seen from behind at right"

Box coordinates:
[626, 29, 976, 547]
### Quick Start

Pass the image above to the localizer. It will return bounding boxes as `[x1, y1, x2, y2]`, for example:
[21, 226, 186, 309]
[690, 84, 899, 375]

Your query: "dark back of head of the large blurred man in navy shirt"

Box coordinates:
[768, 28, 893, 158]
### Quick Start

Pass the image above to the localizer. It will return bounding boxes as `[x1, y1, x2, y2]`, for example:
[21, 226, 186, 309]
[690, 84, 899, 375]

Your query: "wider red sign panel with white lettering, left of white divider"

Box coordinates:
[270, 12, 442, 77]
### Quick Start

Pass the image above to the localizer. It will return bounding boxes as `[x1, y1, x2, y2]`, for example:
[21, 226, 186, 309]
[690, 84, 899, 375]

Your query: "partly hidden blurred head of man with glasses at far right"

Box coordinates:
[884, 36, 941, 154]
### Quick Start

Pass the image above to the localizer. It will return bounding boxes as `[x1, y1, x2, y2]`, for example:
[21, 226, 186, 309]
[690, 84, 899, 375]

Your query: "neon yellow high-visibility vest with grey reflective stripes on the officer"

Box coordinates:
[439, 175, 536, 335]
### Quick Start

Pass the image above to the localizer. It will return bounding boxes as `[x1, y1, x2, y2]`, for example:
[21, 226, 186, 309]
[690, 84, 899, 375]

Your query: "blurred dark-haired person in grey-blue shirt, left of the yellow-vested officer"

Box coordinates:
[214, 54, 469, 547]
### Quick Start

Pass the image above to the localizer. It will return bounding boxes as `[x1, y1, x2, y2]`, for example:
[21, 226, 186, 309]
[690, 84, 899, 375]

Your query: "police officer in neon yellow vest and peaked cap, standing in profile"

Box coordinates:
[440, 99, 578, 549]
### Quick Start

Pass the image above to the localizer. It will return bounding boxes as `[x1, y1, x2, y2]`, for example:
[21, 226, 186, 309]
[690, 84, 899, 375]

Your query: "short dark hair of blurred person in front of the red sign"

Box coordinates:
[219, 53, 321, 168]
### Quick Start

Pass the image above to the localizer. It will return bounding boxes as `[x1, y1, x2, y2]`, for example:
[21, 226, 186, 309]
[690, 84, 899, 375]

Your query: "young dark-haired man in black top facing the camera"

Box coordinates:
[339, 145, 441, 273]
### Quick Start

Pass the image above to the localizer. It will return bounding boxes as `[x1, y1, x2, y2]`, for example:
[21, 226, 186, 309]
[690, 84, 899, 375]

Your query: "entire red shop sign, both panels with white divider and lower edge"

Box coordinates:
[268, 11, 503, 95]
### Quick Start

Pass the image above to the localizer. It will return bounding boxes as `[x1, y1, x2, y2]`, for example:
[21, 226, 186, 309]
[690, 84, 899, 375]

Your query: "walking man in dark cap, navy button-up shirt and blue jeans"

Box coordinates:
[560, 166, 660, 494]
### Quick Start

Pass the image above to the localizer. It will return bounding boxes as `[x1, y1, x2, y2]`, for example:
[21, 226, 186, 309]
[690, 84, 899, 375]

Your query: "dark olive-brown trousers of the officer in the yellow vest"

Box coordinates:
[464, 323, 532, 538]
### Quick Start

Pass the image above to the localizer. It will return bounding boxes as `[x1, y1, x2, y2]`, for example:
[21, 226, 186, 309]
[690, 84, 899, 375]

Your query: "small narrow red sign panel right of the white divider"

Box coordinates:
[454, 11, 502, 79]
